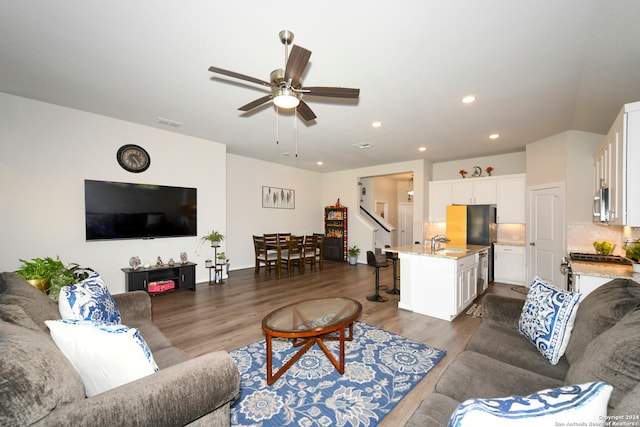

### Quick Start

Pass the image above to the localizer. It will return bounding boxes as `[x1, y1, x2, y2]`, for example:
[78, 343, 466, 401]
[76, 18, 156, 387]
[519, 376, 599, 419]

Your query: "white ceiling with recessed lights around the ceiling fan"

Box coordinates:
[0, 0, 640, 172]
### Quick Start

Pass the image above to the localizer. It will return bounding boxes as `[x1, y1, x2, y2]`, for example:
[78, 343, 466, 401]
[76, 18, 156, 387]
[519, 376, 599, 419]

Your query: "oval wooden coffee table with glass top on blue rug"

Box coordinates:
[262, 298, 362, 385]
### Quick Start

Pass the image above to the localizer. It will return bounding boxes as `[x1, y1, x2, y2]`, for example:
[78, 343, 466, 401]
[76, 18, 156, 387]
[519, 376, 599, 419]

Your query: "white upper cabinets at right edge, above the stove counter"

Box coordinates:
[594, 102, 640, 227]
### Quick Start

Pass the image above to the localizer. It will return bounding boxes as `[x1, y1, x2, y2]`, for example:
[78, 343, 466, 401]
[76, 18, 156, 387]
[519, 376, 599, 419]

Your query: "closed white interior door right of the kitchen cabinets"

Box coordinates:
[527, 183, 566, 289]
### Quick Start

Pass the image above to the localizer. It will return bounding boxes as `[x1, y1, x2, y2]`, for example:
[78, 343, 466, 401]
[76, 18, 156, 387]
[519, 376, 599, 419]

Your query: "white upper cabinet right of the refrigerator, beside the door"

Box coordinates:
[496, 174, 526, 224]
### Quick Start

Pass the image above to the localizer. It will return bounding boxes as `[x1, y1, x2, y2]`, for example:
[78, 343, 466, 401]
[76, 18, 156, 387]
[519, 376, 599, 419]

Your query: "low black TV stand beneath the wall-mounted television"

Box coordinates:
[121, 262, 197, 292]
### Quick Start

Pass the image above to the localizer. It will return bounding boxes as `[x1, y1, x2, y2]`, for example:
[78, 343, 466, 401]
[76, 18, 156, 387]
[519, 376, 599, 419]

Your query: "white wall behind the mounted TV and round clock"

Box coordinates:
[0, 93, 226, 293]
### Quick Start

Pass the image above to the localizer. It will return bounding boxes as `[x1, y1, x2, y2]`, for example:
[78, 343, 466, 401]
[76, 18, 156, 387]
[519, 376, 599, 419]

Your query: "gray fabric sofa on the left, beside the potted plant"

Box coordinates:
[0, 273, 240, 426]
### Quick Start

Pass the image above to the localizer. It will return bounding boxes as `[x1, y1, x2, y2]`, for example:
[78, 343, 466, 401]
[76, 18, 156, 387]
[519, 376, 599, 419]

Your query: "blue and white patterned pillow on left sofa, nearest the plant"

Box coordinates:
[58, 272, 120, 323]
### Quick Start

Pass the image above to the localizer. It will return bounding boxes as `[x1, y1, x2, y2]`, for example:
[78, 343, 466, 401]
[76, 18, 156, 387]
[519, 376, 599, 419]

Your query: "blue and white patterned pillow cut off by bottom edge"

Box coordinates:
[449, 382, 613, 427]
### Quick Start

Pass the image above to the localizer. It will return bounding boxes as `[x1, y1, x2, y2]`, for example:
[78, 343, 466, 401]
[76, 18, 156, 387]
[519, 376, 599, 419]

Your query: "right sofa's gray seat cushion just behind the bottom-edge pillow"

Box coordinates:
[435, 351, 564, 402]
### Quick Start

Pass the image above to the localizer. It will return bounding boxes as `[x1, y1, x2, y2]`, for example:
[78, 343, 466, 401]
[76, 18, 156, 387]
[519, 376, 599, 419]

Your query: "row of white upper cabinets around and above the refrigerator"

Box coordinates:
[429, 174, 526, 224]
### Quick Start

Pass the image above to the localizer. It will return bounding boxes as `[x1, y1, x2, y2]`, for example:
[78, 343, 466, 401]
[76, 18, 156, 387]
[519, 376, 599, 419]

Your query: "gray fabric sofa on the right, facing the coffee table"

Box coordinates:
[407, 279, 640, 427]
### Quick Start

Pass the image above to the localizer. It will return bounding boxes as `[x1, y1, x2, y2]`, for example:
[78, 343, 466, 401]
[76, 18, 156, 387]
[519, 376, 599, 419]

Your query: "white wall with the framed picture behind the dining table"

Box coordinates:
[225, 154, 324, 270]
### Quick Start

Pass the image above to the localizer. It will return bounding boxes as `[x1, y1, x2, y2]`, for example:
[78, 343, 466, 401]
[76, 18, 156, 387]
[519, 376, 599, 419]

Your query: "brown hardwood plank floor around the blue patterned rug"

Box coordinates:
[152, 261, 515, 427]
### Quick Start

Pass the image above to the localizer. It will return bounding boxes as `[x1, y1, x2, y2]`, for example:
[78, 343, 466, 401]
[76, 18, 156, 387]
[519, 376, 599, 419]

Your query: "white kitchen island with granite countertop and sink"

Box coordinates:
[385, 244, 489, 321]
